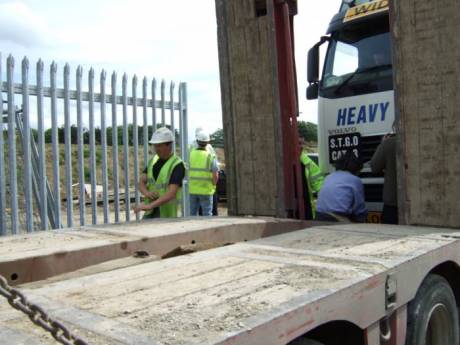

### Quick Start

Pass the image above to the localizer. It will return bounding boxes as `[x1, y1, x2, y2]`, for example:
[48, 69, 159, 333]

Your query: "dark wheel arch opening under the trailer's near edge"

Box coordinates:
[288, 320, 364, 345]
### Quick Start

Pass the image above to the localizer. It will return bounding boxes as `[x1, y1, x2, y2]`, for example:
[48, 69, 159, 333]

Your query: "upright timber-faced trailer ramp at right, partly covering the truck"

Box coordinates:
[390, 0, 460, 227]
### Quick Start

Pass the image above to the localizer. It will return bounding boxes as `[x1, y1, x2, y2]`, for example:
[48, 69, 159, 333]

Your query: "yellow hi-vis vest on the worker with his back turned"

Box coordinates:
[189, 149, 216, 195]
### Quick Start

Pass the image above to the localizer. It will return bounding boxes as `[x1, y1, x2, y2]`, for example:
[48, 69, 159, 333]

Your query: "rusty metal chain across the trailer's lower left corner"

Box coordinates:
[0, 275, 88, 345]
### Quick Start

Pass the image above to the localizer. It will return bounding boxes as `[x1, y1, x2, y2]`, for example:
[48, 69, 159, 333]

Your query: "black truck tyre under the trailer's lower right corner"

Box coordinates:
[406, 274, 459, 345]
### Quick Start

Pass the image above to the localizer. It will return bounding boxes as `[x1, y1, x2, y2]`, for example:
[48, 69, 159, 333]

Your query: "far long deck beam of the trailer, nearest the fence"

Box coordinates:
[0, 217, 309, 284]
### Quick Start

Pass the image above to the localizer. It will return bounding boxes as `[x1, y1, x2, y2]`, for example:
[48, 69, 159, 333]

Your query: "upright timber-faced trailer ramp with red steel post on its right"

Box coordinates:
[216, 0, 284, 217]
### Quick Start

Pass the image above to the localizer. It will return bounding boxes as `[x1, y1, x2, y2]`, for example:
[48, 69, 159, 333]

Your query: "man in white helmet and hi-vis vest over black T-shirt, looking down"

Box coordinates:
[134, 127, 185, 219]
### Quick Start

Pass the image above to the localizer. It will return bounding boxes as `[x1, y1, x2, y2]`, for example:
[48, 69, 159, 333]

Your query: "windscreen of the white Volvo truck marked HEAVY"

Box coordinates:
[320, 16, 393, 98]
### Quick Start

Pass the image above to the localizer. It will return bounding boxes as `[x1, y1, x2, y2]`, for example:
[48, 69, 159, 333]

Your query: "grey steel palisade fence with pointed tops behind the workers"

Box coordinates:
[0, 55, 189, 235]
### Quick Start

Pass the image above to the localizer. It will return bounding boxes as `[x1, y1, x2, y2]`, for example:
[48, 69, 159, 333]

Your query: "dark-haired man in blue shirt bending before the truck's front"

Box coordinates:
[316, 151, 367, 222]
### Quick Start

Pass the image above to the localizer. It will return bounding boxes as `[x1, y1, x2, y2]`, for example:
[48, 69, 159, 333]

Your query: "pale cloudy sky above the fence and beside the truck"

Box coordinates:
[0, 0, 340, 133]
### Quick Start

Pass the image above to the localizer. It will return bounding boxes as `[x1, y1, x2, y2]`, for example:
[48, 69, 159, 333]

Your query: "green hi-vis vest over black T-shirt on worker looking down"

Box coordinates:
[144, 155, 183, 218]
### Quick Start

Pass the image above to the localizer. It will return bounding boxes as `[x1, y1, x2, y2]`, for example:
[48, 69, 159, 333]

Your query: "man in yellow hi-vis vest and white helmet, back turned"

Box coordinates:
[189, 131, 219, 216]
